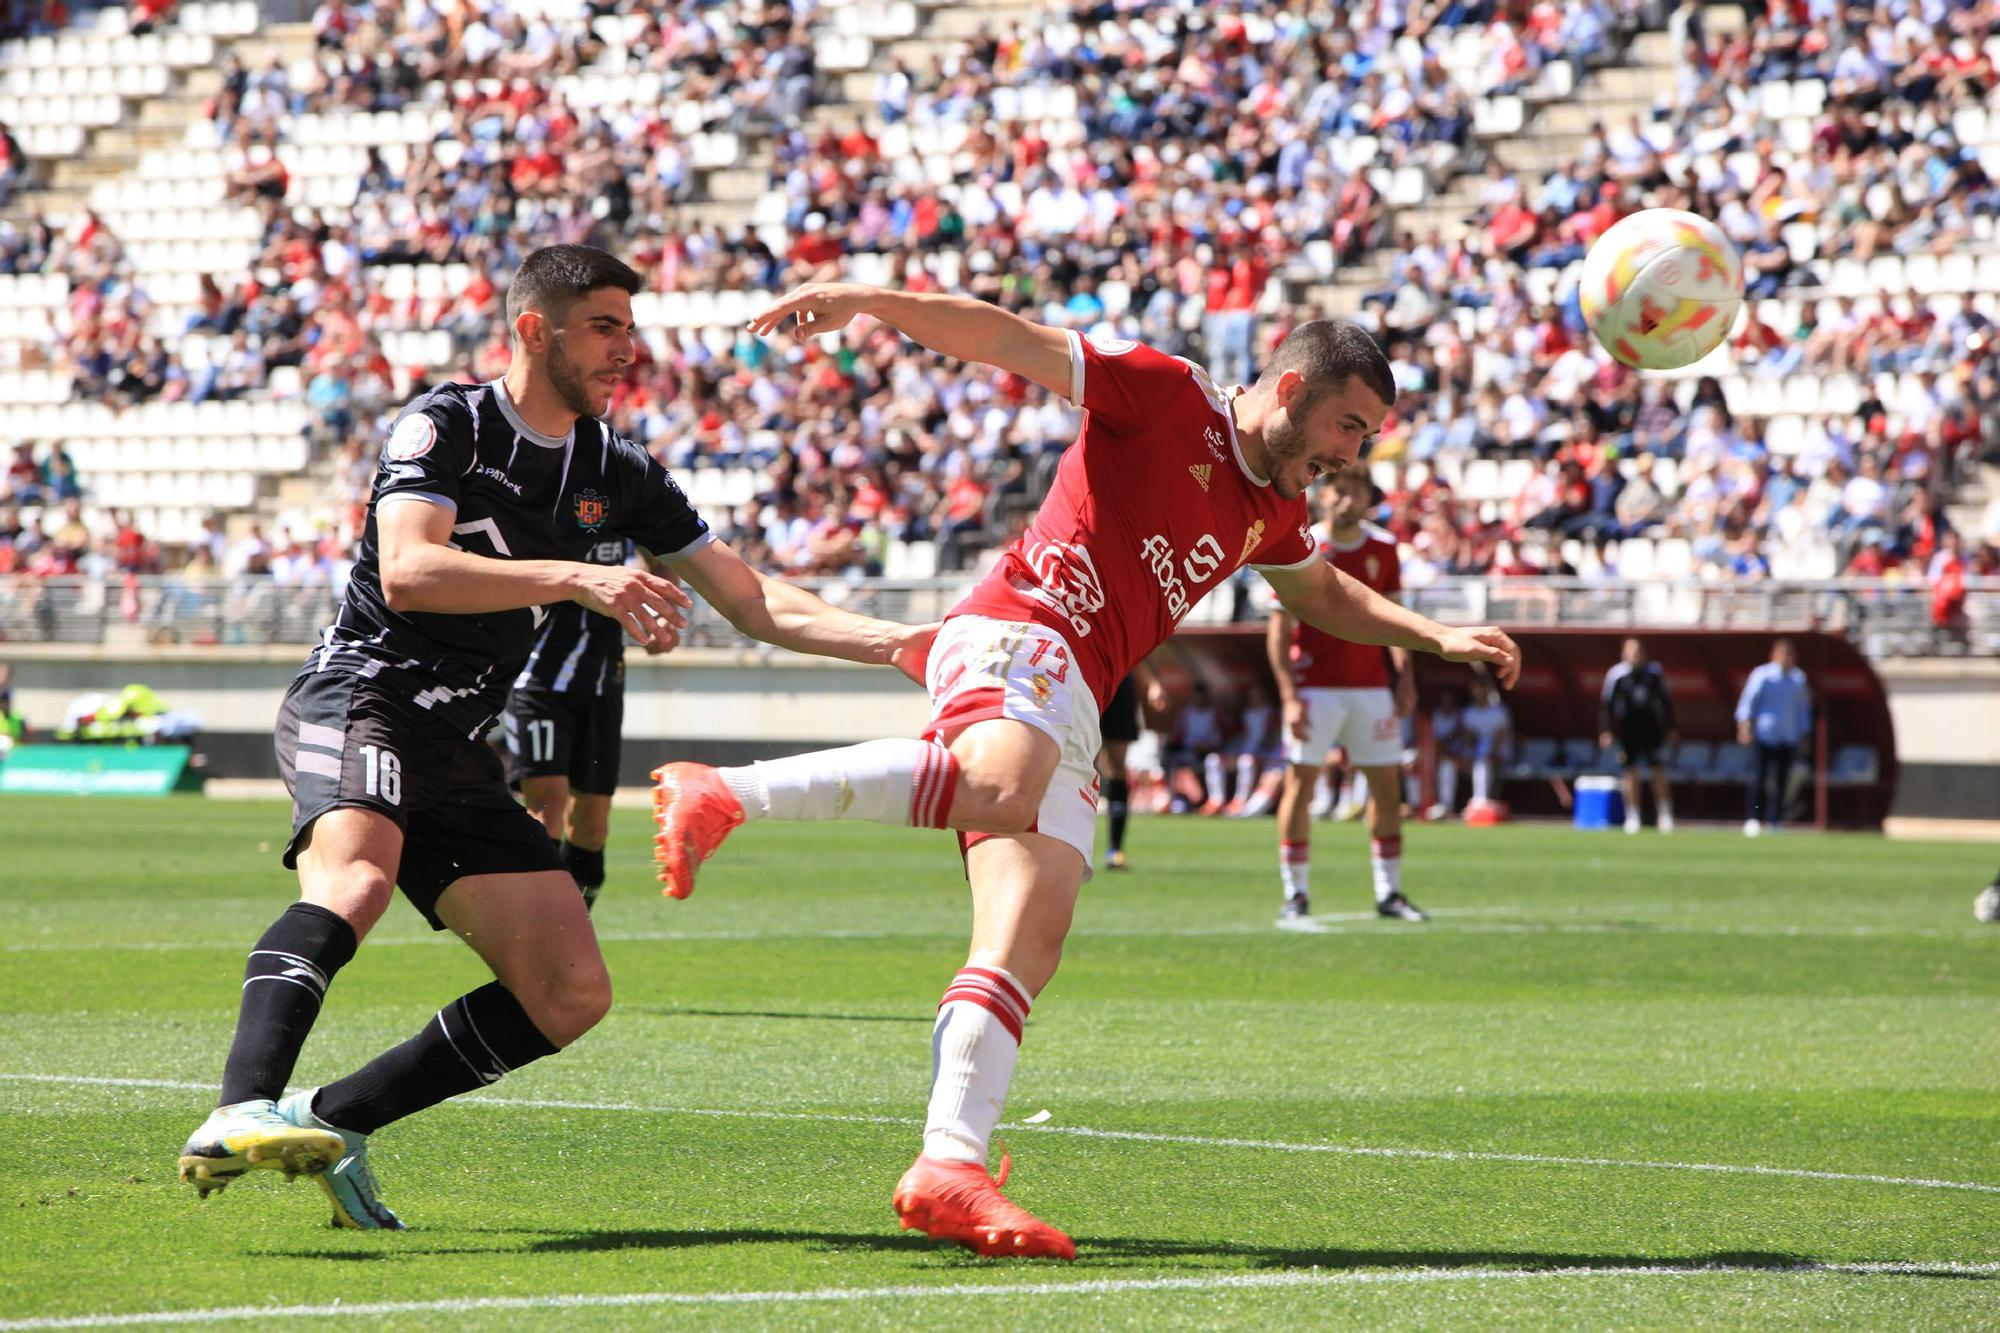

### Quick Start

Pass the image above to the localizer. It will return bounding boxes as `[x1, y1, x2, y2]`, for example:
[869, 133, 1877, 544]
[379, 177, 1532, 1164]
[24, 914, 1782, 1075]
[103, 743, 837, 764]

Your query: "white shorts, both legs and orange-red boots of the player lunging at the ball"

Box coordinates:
[656, 616, 1098, 1259]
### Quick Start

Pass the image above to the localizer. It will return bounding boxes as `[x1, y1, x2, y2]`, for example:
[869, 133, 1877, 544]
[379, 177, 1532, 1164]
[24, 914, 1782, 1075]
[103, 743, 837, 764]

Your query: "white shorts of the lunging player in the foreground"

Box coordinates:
[924, 616, 1098, 877]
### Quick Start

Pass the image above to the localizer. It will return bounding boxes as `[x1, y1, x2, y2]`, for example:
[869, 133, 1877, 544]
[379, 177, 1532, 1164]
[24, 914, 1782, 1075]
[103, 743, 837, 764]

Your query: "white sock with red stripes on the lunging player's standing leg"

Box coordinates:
[924, 967, 1032, 1165]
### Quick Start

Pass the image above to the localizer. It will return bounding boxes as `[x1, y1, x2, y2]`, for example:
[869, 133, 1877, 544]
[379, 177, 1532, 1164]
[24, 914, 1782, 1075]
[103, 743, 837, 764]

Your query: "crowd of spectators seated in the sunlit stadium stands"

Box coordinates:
[0, 0, 2000, 616]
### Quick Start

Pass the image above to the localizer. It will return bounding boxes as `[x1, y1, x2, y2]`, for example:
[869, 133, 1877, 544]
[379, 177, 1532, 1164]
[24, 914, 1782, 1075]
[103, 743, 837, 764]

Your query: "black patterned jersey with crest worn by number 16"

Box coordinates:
[304, 380, 714, 737]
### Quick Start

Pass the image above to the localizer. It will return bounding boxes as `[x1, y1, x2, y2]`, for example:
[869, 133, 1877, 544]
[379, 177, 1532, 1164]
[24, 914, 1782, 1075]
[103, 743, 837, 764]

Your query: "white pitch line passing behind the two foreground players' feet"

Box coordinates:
[0, 1073, 2000, 1195]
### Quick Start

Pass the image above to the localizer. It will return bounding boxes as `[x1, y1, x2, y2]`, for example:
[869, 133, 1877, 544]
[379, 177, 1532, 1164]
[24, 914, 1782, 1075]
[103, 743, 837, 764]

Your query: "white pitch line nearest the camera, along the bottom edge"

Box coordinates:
[0, 1263, 2000, 1333]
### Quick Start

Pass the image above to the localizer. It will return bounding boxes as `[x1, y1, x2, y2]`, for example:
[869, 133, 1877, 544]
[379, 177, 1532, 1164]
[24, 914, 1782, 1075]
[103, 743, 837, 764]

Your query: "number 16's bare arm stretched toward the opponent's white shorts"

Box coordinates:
[680, 542, 938, 685]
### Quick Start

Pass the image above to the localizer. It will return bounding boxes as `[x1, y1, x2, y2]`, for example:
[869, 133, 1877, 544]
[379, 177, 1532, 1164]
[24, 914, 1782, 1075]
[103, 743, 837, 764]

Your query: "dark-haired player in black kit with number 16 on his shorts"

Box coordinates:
[180, 246, 936, 1229]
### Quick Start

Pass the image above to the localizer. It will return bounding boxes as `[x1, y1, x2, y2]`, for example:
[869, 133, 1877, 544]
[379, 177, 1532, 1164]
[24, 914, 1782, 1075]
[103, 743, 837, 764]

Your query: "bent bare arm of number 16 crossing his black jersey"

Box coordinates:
[376, 500, 692, 646]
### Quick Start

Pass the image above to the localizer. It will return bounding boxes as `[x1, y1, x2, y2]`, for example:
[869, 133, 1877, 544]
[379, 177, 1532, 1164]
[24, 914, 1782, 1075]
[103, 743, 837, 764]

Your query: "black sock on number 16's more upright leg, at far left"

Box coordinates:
[222, 903, 356, 1107]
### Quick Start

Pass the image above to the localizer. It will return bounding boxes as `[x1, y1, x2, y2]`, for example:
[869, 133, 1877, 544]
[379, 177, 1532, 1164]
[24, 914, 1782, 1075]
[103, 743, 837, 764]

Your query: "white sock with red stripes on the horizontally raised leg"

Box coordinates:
[716, 741, 958, 829]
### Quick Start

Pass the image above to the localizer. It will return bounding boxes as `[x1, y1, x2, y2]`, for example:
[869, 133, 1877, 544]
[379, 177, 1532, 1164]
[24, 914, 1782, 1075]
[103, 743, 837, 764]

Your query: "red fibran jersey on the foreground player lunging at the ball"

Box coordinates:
[952, 332, 1318, 705]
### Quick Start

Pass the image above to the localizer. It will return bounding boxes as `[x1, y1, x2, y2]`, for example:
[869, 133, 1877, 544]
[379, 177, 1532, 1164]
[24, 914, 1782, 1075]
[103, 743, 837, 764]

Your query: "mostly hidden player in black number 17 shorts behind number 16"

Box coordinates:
[500, 536, 672, 909]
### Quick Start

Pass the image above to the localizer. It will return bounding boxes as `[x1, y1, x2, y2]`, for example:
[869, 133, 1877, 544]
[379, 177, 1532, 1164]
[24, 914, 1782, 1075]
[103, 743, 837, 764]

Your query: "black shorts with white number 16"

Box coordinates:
[276, 671, 564, 931]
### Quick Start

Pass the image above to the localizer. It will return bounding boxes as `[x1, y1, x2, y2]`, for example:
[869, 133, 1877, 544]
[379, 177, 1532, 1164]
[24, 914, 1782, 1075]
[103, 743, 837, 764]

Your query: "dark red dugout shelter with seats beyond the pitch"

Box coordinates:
[1148, 622, 1896, 829]
